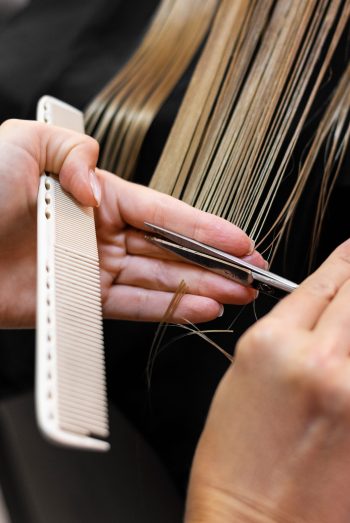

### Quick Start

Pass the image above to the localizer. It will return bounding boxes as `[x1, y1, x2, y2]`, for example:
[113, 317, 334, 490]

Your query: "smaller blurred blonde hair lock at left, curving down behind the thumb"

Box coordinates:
[85, 0, 218, 179]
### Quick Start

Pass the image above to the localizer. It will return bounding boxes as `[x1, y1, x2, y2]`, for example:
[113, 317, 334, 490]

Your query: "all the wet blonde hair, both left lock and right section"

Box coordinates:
[86, 0, 350, 266]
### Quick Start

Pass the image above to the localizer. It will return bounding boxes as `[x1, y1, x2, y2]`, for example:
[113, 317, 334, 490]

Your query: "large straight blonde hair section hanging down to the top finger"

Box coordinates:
[151, 0, 349, 262]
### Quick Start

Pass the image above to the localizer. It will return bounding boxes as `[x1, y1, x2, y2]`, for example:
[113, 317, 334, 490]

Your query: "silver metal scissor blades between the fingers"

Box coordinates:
[145, 222, 298, 298]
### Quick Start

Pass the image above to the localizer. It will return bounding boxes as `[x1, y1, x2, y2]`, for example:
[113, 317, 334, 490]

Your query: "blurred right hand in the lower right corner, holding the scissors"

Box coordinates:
[186, 240, 350, 523]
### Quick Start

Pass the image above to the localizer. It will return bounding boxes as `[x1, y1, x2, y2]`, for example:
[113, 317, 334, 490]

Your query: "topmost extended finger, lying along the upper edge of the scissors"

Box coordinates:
[98, 170, 254, 256]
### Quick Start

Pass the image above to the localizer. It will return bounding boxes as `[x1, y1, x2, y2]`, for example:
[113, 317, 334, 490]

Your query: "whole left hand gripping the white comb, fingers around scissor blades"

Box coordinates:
[0, 120, 265, 327]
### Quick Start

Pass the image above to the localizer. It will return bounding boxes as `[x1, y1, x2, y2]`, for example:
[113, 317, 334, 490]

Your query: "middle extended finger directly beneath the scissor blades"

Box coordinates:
[115, 255, 256, 305]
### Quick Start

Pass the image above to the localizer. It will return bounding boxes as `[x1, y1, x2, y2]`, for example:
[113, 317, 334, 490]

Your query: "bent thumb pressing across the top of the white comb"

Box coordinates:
[1, 120, 100, 206]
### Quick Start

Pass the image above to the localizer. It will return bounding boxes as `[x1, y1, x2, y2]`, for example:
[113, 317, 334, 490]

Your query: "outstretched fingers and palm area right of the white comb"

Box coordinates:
[95, 170, 264, 322]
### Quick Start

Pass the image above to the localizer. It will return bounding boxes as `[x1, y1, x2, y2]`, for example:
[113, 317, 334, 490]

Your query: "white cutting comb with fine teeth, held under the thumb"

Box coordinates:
[35, 96, 109, 450]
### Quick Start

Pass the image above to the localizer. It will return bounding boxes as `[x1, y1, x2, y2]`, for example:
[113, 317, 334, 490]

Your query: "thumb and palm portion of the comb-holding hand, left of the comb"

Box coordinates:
[0, 120, 98, 327]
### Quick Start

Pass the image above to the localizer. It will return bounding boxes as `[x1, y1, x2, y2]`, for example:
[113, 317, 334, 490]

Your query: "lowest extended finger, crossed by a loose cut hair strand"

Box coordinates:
[103, 285, 222, 323]
